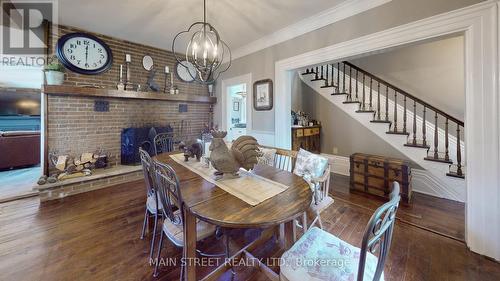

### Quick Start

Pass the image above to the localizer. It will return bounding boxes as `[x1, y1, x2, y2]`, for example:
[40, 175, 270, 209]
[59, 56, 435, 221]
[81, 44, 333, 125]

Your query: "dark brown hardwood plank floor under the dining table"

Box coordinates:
[0, 178, 500, 281]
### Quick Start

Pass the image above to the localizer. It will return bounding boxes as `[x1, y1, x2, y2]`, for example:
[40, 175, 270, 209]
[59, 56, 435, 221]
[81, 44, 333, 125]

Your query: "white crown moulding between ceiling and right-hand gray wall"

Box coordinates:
[232, 0, 392, 59]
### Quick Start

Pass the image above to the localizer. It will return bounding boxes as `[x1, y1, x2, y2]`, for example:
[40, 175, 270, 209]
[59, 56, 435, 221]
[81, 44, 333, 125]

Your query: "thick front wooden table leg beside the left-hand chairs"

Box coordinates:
[183, 208, 196, 281]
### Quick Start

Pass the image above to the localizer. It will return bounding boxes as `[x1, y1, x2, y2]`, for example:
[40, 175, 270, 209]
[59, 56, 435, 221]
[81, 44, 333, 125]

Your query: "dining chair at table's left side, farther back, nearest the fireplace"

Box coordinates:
[139, 148, 162, 259]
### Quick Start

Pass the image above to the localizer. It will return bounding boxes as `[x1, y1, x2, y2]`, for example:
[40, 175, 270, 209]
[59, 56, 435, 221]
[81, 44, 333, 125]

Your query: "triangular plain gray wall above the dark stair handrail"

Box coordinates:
[350, 36, 465, 121]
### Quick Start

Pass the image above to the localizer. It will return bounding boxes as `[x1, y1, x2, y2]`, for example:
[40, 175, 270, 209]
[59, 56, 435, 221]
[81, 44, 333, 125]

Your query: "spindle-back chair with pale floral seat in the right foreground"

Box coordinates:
[280, 182, 401, 281]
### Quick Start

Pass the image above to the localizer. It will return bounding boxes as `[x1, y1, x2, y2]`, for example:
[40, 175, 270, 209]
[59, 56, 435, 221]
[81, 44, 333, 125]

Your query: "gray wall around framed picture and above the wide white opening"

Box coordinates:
[214, 0, 482, 131]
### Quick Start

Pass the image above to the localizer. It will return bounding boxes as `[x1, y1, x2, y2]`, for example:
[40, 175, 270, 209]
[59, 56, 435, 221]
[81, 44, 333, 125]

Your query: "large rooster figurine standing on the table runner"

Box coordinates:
[209, 131, 259, 177]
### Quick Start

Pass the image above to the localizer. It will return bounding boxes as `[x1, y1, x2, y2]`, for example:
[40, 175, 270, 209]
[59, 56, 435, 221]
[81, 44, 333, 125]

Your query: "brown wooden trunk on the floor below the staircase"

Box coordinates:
[350, 153, 412, 203]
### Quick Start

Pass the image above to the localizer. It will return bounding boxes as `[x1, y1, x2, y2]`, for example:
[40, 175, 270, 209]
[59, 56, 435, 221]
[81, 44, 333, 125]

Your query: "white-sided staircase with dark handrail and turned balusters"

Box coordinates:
[301, 61, 465, 201]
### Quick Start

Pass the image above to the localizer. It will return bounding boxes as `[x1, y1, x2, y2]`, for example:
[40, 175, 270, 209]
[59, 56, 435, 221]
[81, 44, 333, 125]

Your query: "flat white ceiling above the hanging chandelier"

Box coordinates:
[58, 0, 344, 50]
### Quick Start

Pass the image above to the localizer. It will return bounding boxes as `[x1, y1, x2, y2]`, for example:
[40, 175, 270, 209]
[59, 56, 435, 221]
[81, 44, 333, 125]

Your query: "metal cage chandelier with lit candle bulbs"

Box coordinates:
[172, 0, 231, 84]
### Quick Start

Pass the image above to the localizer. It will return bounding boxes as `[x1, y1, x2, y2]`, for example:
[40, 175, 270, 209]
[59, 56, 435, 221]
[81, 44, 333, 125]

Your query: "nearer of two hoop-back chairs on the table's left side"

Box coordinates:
[153, 161, 225, 280]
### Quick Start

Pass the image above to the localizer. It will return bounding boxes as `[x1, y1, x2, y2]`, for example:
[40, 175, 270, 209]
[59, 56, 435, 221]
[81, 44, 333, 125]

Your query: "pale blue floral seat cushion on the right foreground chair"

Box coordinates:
[280, 227, 384, 281]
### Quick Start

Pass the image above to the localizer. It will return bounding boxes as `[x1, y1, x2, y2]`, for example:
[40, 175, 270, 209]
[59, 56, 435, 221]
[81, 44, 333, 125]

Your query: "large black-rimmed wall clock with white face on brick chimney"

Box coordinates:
[56, 32, 113, 75]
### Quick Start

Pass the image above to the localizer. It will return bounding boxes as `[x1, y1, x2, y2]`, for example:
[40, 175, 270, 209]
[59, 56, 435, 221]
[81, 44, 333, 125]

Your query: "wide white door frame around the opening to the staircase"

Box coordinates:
[275, 0, 500, 260]
